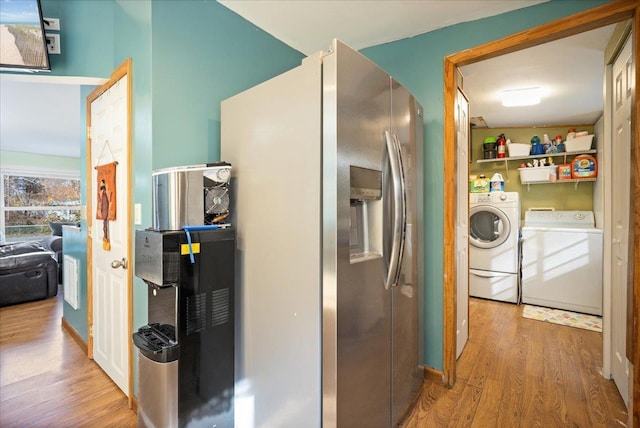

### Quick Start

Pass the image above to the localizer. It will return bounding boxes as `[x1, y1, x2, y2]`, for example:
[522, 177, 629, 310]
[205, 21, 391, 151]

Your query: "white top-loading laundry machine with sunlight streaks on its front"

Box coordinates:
[522, 211, 602, 315]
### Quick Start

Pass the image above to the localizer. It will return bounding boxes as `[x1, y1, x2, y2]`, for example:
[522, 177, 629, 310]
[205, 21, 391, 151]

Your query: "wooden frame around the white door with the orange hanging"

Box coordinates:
[86, 58, 134, 408]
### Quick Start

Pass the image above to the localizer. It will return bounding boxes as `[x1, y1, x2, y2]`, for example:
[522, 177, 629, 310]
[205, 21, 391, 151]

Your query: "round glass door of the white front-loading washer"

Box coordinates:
[469, 205, 511, 248]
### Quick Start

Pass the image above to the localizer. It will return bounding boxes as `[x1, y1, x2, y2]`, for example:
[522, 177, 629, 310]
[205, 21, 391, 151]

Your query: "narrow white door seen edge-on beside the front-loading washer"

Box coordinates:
[456, 89, 470, 359]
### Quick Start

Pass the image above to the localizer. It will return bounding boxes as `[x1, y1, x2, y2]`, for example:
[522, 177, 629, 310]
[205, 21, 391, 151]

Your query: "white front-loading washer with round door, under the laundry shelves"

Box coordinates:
[469, 192, 520, 303]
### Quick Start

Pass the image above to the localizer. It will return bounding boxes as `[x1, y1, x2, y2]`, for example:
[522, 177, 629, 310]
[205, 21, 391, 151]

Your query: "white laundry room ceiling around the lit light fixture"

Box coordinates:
[461, 24, 615, 127]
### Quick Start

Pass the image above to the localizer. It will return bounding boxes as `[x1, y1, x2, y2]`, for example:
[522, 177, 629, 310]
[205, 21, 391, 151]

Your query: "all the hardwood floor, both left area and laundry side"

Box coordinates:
[0, 297, 627, 428]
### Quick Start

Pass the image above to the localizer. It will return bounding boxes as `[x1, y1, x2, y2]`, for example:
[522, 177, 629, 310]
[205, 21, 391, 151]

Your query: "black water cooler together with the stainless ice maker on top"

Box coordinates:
[133, 164, 235, 428]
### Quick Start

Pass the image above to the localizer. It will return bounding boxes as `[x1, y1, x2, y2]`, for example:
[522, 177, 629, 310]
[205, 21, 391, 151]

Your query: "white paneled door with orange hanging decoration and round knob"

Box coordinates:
[87, 67, 131, 395]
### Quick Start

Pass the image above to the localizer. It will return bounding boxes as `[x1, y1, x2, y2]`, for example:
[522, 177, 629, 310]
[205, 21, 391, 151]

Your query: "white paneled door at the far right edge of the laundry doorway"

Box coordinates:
[611, 37, 635, 406]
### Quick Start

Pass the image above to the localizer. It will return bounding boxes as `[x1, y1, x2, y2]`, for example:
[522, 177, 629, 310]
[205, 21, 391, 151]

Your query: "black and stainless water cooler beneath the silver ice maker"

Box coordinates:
[133, 228, 235, 428]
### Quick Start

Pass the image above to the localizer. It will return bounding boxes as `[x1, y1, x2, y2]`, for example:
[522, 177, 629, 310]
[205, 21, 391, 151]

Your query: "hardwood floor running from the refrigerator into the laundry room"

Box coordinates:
[403, 298, 627, 428]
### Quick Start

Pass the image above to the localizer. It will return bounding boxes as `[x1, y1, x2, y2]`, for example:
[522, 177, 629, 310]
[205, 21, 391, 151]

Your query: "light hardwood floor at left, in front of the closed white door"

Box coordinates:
[0, 296, 136, 428]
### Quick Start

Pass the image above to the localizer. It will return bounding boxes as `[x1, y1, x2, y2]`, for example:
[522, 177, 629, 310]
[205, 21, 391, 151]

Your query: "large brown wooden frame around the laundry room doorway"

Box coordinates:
[443, 0, 640, 426]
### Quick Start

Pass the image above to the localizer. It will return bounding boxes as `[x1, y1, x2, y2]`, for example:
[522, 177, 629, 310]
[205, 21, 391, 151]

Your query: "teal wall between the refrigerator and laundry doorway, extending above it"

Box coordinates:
[362, 0, 607, 369]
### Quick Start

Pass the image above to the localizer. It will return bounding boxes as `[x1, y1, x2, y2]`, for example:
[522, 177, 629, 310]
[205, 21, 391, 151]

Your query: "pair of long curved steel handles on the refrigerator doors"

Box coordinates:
[384, 131, 406, 290]
